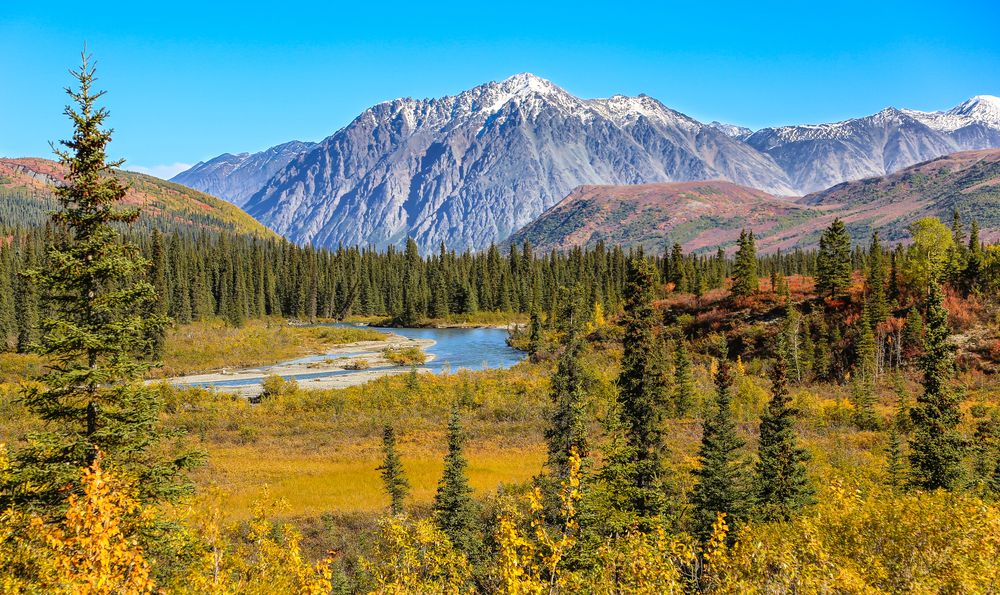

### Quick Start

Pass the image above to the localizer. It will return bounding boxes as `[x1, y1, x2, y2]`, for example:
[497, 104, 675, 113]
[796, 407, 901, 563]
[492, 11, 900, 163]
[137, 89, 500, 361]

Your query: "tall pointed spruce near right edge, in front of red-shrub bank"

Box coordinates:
[909, 281, 965, 490]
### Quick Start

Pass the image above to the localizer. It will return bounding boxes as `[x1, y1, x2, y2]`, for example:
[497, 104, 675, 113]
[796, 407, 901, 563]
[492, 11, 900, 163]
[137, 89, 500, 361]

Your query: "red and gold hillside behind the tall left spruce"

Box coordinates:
[0, 158, 275, 237]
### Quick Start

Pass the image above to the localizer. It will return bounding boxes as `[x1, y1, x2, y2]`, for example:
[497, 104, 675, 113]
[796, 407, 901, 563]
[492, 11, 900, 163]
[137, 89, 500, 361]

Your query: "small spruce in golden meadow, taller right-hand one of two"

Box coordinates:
[434, 403, 482, 559]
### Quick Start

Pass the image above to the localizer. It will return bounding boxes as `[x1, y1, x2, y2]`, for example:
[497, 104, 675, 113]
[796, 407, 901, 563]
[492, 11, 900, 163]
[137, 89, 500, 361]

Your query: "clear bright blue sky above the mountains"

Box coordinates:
[0, 0, 1000, 177]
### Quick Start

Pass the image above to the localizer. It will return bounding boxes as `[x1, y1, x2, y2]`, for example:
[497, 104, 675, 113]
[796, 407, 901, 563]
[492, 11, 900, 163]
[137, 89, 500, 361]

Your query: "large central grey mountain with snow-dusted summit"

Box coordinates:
[238, 73, 797, 250]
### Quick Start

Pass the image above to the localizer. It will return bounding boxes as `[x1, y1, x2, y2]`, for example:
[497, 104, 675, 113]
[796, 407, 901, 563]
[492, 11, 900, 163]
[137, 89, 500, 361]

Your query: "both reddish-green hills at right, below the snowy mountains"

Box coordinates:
[508, 149, 1000, 253]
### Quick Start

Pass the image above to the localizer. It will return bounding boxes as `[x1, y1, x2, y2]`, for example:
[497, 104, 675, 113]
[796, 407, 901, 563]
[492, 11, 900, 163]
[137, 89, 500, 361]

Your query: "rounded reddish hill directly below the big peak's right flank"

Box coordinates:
[509, 180, 820, 253]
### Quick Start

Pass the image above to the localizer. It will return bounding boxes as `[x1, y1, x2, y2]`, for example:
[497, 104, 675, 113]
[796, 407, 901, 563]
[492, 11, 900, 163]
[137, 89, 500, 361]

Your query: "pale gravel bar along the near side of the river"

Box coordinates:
[162, 333, 436, 398]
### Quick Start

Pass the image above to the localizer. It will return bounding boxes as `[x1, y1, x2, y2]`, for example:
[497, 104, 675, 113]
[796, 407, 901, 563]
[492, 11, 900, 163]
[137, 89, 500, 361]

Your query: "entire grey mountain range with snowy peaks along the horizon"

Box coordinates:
[172, 73, 1000, 252]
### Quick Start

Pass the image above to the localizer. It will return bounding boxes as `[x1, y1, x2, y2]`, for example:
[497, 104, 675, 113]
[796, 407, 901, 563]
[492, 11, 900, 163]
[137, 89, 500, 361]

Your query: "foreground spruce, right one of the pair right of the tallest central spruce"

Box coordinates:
[754, 346, 816, 520]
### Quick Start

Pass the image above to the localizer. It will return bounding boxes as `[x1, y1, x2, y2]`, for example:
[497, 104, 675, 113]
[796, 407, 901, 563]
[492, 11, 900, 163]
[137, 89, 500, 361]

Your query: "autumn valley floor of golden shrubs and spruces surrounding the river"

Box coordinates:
[0, 53, 1000, 594]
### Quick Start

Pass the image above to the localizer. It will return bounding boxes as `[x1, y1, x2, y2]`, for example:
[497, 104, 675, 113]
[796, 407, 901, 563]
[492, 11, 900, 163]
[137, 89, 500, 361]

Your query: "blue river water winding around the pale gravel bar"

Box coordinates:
[184, 323, 524, 387]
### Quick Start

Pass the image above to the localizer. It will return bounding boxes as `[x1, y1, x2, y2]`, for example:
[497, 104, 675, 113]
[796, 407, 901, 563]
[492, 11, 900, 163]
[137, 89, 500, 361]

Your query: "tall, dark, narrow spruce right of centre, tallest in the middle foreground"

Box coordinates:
[618, 257, 668, 525]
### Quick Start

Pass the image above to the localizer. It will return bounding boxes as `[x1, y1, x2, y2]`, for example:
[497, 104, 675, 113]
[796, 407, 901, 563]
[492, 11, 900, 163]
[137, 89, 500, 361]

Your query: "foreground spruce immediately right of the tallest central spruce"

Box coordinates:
[690, 355, 748, 539]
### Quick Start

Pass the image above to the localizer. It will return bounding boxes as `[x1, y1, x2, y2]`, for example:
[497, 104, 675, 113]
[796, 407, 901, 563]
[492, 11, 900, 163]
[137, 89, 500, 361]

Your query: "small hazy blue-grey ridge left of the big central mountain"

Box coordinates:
[170, 141, 316, 208]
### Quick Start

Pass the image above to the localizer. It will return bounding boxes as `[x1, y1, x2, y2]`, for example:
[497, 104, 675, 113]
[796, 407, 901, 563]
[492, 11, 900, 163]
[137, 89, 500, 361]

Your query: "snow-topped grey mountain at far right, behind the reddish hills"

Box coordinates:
[745, 95, 1000, 194]
